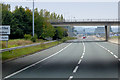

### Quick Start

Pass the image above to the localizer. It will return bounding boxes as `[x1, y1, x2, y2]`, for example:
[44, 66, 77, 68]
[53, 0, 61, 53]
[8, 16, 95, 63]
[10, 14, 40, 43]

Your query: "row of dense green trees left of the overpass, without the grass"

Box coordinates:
[1, 4, 68, 39]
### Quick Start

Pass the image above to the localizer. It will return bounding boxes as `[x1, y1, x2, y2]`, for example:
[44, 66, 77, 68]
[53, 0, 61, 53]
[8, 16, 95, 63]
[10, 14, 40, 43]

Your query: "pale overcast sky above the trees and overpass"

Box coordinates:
[4, 0, 118, 19]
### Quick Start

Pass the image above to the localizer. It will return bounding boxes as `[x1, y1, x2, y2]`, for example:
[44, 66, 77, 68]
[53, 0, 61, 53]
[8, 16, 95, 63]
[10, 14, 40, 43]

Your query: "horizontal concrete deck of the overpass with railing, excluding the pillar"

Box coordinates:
[51, 19, 120, 26]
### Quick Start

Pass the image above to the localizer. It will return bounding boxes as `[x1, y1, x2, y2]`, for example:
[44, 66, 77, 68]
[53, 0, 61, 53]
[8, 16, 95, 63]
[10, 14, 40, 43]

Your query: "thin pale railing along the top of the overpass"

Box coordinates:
[50, 19, 120, 23]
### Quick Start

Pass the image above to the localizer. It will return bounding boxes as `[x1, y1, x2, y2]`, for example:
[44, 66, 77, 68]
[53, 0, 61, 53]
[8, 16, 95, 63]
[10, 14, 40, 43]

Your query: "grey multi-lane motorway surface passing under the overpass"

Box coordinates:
[3, 36, 120, 80]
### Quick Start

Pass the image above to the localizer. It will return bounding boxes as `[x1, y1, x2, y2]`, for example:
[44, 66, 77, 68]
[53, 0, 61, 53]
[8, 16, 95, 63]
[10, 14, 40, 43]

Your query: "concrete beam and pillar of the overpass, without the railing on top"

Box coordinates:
[51, 21, 118, 41]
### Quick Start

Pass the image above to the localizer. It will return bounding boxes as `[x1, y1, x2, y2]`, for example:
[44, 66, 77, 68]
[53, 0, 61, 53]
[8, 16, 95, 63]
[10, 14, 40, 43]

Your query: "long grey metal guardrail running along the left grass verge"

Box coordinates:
[0, 40, 56, 53]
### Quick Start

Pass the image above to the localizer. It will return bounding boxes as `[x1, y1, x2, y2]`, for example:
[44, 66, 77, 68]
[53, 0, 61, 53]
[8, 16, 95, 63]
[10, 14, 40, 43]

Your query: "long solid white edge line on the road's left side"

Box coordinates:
[4, 43, 72, 79]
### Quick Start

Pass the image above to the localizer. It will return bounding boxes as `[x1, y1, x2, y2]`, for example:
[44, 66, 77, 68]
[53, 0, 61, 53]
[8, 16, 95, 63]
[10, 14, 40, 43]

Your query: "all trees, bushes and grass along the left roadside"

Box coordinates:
[0, 4, 75, 60]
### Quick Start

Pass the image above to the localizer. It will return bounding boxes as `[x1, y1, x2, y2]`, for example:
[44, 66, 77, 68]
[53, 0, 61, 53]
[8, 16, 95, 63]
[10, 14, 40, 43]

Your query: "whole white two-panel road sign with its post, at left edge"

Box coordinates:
[0, 26, 10, 47]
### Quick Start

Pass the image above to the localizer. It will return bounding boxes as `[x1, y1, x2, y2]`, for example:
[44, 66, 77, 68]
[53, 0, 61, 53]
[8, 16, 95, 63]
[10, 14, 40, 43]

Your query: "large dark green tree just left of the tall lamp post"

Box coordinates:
[10, 6, 31, 39]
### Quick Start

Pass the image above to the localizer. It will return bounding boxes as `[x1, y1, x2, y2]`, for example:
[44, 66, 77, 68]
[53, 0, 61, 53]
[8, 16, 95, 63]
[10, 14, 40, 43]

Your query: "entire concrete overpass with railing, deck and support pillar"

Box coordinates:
[50, 19, 120, 41]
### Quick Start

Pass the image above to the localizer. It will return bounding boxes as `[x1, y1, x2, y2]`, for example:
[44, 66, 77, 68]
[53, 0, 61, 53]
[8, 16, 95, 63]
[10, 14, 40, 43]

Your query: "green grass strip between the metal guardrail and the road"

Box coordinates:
[2, 37, 75, 61]
